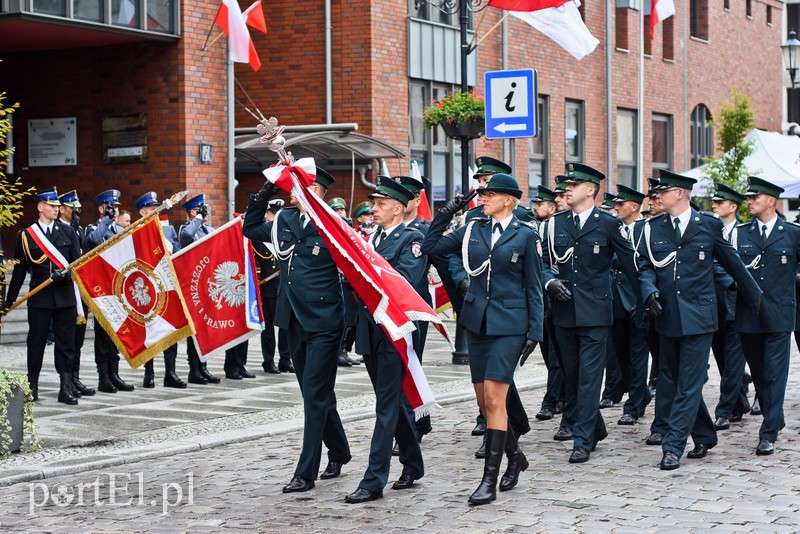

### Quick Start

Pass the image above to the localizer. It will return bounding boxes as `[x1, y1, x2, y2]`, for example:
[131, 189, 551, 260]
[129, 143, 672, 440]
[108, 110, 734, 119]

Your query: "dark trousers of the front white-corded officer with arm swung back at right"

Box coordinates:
[656, 333, 717, 457]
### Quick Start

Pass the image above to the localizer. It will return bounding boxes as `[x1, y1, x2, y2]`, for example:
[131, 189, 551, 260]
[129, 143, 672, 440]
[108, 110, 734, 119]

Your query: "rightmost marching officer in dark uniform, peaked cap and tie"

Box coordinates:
[731, 176, 800, 456]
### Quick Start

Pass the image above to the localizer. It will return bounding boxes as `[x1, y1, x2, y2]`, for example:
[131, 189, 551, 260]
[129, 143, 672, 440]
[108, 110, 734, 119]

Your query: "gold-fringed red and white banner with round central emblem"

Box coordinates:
[72, 217, 194, 369]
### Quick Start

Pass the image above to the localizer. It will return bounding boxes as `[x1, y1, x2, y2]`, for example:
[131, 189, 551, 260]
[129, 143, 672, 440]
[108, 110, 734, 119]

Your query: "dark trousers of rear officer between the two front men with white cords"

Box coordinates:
[611, 317, 651, 419]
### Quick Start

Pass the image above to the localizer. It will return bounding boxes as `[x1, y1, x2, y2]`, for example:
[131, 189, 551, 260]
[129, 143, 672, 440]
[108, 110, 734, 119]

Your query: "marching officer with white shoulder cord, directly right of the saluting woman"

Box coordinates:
[543, 163, 638, 463]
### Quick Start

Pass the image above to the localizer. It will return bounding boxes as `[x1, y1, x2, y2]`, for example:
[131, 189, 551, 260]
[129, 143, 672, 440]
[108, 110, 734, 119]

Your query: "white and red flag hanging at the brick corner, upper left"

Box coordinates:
[215, 0, 267, 71]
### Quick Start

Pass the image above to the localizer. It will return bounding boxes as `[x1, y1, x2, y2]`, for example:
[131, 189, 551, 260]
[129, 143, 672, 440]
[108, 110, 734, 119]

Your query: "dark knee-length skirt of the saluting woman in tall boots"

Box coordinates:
[467, 330, 526, 384]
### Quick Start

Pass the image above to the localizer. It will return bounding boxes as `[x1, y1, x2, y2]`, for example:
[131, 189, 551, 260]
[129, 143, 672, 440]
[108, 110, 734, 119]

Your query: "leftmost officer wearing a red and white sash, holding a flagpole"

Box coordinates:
[6, 191, 80, 405]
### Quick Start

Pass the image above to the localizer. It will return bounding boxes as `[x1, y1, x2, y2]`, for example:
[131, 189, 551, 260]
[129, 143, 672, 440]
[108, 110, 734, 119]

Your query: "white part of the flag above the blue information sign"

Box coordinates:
[511, 0, 600, 61]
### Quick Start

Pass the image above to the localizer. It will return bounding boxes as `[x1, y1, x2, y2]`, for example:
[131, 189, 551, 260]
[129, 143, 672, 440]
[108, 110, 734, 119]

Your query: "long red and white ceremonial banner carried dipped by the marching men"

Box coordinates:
[264, 158, 452, 419]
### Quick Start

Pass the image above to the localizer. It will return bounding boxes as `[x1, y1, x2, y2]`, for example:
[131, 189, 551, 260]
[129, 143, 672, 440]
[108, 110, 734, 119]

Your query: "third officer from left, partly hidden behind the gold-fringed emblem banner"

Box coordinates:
[83, 189, 134, 393]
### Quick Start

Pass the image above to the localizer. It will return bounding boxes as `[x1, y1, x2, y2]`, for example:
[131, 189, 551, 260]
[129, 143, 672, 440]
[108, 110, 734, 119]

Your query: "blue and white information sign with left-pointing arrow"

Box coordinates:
[484, 69, 538, 139]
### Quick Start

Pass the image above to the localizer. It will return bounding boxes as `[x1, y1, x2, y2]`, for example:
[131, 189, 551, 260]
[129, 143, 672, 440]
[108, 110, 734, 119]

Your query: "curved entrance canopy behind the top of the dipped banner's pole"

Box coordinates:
[235, 125, 406, 172]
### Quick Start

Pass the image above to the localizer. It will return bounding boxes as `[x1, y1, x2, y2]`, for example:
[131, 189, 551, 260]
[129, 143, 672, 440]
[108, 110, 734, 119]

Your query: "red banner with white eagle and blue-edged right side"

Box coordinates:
[172, 217, 264, 360]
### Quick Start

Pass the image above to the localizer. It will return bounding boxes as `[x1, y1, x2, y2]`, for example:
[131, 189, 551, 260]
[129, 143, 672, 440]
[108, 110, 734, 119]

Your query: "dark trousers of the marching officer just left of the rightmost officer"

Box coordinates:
[711, 321, 750, 419]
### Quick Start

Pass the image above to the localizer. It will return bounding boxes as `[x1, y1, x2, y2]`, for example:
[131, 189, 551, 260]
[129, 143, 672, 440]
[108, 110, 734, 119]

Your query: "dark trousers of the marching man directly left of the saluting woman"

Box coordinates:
[358, 325, 425, 492]
